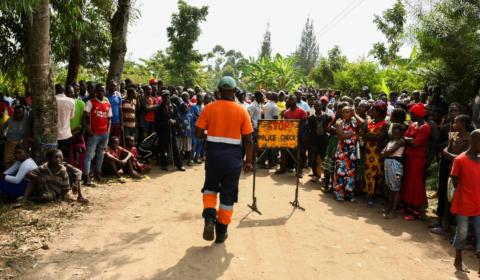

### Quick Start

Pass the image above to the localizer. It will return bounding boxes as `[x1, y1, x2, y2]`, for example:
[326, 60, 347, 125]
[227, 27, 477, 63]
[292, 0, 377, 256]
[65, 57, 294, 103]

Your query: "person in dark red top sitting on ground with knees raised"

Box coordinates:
[102, 136, 142, 184]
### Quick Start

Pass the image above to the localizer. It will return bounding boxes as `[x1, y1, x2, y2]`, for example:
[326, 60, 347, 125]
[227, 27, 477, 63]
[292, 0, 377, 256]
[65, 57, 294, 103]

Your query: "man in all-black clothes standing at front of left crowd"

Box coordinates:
[155, 90, 185, 171]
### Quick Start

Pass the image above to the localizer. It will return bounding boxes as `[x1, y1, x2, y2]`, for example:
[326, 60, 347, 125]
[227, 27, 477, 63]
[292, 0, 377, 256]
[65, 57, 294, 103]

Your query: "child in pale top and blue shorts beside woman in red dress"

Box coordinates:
[380, 123, 405, 219]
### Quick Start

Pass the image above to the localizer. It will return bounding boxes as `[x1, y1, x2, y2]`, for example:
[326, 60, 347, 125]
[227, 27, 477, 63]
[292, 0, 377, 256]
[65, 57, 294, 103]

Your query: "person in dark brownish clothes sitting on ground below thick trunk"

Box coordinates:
[20, 149, 89, 205]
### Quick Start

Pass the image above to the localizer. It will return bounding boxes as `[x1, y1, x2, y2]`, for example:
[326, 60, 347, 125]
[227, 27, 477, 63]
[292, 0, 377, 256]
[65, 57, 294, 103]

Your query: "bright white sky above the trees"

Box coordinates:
[127, 0, 412, 64]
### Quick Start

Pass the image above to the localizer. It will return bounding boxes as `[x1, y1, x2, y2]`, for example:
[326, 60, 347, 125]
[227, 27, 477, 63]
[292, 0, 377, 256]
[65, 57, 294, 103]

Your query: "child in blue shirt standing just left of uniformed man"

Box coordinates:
[177, 102, 193, 166]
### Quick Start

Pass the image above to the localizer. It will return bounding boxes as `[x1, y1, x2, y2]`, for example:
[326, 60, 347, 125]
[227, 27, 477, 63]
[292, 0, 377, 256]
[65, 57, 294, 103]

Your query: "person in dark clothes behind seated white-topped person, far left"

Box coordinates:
[3, 105, 33, 169]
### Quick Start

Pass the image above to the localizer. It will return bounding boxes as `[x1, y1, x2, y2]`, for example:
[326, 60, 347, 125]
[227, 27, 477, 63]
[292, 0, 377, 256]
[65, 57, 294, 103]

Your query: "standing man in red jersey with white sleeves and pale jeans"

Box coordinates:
[82, 84, 112, 186]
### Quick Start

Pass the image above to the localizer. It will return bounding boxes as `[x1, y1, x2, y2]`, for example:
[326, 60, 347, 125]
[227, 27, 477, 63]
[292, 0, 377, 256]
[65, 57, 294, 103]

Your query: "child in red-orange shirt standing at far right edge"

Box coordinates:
[450, 129, 480, 274]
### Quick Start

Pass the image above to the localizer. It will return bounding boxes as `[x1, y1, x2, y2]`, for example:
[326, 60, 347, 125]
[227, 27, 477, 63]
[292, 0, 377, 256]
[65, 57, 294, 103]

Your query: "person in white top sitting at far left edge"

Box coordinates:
[0, 142, 37, 199]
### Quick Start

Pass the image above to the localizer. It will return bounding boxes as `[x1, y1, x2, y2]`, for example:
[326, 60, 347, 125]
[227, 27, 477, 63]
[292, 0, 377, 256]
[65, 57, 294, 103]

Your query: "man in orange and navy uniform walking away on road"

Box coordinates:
[195, 76, 253, 243]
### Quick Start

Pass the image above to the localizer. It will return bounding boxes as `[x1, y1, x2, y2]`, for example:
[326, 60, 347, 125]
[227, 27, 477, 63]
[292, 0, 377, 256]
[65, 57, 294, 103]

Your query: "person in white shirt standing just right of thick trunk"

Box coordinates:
[55, 84, 75, 163]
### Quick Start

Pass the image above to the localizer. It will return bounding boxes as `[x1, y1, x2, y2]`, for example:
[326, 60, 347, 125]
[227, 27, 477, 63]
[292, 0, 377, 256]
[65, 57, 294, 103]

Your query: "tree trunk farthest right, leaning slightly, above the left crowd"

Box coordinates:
[107, 0, 132, 85]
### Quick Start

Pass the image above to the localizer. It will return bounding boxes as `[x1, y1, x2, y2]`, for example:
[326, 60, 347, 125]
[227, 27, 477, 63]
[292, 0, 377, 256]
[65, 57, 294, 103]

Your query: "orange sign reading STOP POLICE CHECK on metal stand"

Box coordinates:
[257, 120, 300, 149]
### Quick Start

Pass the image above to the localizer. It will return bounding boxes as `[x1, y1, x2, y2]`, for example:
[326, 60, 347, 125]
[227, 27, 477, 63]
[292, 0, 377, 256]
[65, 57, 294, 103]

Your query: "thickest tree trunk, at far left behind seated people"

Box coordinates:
[27, 0, 58, 164]
